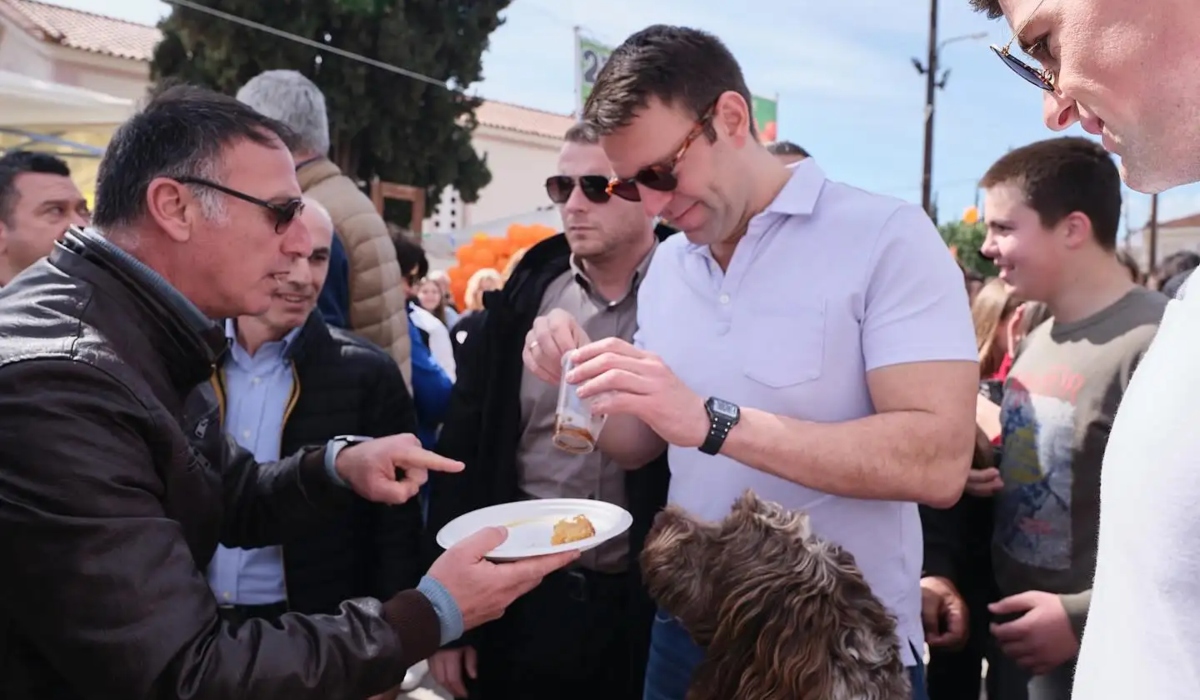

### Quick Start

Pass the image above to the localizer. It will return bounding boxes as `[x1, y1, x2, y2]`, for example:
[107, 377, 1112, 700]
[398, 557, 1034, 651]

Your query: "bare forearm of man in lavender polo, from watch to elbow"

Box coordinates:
[721, 408, 973, 508]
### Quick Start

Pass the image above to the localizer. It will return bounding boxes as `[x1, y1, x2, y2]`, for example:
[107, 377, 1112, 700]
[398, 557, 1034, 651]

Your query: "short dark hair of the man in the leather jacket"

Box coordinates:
[92, 85, 295, 229]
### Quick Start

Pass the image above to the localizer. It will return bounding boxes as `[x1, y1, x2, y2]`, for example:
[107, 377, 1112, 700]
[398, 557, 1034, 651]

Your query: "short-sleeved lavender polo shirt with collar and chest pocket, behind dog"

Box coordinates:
[635, 158, 978, 665]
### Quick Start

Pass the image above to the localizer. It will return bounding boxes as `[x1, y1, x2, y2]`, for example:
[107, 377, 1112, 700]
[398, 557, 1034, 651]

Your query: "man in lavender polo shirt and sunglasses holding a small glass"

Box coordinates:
[526, 25, 979, 700]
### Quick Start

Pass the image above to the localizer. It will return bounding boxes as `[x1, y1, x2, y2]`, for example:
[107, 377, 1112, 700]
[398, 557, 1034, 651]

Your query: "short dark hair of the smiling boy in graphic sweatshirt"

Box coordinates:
[979, 136, 1121, 250]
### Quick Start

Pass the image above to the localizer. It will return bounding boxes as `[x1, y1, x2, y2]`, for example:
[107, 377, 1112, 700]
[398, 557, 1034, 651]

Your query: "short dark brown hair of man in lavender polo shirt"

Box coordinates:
[583, 24, 757, 139]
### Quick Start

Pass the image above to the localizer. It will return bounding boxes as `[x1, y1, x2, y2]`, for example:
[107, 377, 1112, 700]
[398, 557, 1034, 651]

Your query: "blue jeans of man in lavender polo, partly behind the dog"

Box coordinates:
[642, 610, 929, 700]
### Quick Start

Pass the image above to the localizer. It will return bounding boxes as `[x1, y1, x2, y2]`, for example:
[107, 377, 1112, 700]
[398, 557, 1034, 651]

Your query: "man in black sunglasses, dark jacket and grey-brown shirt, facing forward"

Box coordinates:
[428, 124, 671, 700]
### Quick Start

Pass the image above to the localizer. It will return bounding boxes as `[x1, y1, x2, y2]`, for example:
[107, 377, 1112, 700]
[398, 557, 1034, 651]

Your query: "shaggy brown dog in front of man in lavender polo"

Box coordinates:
[641, 491, 912, 700]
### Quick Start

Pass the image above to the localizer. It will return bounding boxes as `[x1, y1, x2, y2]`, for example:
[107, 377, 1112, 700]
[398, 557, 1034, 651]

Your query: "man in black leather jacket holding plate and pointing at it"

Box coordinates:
[0, 86, 572, 700]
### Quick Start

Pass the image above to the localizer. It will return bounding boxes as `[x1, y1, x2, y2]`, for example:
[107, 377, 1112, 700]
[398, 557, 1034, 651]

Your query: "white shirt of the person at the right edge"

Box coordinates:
[1072, 280, 1200, 700]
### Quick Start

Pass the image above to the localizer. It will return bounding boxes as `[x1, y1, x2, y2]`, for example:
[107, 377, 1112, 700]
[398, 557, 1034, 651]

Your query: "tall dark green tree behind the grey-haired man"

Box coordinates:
[151, 0, 511, 220]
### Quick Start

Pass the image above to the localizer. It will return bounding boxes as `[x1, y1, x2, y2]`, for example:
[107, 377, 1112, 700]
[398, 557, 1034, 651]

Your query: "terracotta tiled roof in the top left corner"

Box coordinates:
[0, 0, 162, 61]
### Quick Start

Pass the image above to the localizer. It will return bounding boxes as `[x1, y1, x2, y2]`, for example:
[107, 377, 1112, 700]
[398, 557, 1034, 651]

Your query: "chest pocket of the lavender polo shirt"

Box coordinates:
[742, 304, 826, 389]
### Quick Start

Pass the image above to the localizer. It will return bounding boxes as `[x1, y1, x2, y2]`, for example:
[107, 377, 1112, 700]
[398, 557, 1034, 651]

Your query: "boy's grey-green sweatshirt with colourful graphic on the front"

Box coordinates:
[992, 288, 1166, 629]
